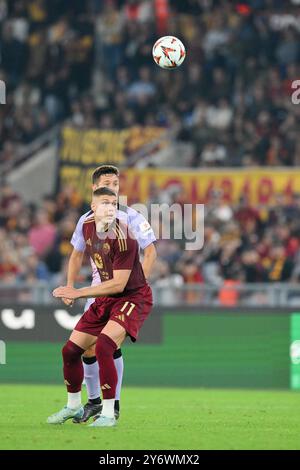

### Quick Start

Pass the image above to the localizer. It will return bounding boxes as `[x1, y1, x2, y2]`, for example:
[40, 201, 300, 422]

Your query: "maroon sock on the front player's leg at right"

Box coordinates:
[96, 333, 118, 400]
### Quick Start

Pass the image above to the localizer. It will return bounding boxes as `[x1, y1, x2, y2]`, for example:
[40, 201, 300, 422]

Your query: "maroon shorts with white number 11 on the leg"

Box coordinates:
[75, 284, 153, 341]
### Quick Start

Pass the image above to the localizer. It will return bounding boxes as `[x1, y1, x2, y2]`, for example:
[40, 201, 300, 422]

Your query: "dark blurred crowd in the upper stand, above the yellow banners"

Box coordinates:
[0, 0, 300, 167]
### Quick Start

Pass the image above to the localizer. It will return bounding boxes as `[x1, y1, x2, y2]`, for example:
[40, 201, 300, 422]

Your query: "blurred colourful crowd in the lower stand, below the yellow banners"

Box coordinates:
[0, 184, 300, 305]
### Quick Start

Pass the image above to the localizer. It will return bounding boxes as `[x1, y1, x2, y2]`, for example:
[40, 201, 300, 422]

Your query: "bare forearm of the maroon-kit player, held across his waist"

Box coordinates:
[53, 269, 131, 300]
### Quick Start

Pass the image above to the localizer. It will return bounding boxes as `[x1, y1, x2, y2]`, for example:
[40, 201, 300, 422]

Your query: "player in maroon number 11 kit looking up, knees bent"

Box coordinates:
[47, 188, 153, 427]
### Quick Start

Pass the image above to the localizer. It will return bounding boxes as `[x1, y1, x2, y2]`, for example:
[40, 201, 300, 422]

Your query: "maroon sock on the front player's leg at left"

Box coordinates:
[62, 340, 84, 393]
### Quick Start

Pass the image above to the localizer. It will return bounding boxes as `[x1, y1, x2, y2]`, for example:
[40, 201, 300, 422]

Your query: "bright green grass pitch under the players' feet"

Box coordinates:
[0, 385, 300, 450]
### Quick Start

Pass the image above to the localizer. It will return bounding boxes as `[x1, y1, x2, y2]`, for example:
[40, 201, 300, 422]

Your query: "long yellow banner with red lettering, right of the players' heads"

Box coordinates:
[121, 168, 300, 205]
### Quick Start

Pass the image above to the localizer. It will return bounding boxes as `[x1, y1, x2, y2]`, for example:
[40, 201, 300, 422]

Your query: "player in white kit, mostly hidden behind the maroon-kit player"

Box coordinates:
[63, 165, 156, 423]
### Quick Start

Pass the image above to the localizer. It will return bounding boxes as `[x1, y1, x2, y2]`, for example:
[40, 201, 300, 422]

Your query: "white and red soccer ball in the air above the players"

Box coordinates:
[152, 36, 186, 69]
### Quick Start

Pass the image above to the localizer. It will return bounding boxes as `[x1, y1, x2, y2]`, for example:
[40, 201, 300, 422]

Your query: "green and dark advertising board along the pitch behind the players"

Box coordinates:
[0, 305, 300, 389]
